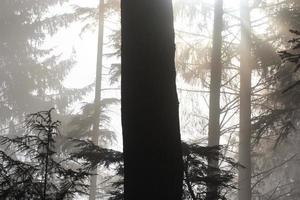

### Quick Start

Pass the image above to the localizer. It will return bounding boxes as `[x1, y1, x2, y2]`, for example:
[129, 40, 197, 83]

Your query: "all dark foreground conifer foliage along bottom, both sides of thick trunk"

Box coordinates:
[0, 109, 237, 200]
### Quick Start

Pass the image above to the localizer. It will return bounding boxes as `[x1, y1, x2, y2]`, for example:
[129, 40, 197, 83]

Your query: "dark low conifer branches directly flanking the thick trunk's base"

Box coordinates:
[72, 139, 238, 200]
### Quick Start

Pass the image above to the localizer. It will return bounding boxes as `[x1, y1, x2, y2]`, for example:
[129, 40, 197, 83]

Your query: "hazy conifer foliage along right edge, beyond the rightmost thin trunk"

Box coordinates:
[253, 0, 300, 195]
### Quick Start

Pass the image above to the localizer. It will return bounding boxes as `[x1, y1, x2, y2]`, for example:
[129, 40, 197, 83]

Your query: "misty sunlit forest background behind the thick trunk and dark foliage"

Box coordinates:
[0, 0, 300, 200]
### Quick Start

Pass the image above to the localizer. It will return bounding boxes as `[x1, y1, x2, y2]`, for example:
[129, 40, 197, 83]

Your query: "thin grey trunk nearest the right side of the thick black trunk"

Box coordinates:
[206, 0, 223, 200]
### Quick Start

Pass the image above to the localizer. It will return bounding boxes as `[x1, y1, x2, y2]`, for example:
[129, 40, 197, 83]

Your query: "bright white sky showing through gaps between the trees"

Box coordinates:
[45, 0, 263, 149]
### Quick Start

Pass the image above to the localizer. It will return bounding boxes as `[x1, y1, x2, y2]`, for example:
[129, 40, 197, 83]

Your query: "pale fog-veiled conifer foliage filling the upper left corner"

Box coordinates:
[0, 0, 90, 125]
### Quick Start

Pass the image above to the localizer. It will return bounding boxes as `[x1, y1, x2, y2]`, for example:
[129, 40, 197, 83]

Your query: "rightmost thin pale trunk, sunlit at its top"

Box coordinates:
[238, 0, 252, 200]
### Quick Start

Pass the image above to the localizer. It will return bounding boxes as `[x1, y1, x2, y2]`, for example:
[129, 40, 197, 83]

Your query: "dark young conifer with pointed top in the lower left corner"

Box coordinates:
[0, 109, 90, 200]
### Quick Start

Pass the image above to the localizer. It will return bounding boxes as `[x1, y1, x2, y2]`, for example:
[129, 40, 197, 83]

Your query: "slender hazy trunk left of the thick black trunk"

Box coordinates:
[89, 0, 104, 200]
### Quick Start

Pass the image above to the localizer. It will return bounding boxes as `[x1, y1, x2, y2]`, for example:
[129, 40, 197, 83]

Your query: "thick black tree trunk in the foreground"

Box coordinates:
[121, 0, 183, 200]
